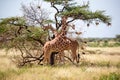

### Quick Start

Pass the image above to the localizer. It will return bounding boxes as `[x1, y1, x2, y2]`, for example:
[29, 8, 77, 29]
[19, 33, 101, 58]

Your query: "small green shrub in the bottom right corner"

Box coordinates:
[99, 72, 120, 80]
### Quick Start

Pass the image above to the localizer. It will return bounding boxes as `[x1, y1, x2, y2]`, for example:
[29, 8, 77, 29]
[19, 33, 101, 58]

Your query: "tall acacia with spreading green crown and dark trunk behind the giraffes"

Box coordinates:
[39, 0, 111, 63]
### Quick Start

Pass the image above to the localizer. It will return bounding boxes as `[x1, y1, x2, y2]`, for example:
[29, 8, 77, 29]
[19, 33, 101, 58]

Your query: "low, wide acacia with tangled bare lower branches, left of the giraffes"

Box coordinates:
[0, 17, 47, 66]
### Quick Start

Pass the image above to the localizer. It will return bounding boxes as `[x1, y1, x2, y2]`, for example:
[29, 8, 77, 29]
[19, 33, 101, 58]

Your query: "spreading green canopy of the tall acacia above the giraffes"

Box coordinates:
[44, 0, 111, 25]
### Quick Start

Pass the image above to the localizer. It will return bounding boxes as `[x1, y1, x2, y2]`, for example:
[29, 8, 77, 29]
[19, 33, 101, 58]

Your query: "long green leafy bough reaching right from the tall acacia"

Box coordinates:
[60, 4, 111, 24]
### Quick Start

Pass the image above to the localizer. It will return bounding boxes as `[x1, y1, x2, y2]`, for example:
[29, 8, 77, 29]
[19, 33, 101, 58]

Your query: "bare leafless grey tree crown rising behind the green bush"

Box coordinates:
[22, 3, 51, 27]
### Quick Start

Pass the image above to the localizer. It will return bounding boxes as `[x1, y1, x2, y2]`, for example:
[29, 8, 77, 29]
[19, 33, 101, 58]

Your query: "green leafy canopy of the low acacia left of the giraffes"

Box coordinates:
[0, 17, 47, 49]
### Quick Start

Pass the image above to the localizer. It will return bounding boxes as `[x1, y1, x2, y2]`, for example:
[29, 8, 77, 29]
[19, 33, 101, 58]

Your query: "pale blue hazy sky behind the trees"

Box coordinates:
[0, 0, 120, 38]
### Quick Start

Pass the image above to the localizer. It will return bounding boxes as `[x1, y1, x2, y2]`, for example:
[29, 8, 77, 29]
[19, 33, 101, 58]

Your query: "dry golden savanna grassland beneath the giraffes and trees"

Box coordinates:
[0, 47, 120, 80]
